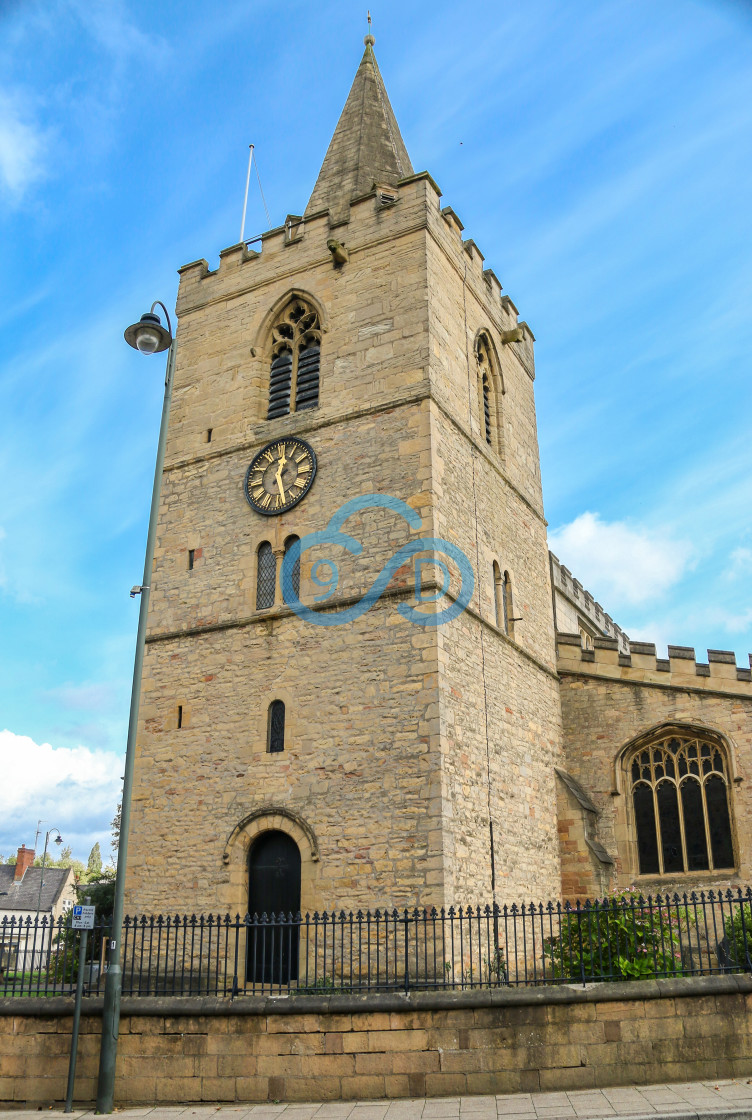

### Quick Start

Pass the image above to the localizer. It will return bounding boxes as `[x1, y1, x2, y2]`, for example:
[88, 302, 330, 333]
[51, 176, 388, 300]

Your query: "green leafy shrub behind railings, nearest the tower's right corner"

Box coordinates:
[544, 889, 687, 981]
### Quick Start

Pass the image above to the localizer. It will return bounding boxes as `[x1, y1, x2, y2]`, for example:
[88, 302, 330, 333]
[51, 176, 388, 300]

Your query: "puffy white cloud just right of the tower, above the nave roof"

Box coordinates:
[548, 513, 693, 613]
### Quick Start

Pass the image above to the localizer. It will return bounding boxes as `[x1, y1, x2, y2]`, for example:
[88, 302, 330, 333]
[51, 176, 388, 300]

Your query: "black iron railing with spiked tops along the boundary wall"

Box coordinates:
[0, 888, 752, 997]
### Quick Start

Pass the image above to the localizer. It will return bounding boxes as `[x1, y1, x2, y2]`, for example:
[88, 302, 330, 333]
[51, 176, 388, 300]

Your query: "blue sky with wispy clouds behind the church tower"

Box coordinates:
[0, 0, 752, 860]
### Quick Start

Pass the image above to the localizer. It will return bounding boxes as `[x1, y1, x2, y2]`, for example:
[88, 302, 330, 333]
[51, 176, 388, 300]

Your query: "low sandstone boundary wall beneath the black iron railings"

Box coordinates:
[0, 976, 752, 1108]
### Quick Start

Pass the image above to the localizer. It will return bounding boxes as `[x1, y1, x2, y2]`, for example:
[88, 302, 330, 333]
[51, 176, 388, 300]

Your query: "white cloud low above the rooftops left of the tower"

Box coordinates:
[0, 730, 123, 860]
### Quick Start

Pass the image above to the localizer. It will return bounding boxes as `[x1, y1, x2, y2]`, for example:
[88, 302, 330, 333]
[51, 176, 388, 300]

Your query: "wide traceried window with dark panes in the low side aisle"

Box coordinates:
[629, 729, 734, 875]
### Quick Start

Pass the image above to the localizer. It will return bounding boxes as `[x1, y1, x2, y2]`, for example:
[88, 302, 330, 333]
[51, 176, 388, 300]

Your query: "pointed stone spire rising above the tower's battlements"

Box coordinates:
[306, 35, 414, 223]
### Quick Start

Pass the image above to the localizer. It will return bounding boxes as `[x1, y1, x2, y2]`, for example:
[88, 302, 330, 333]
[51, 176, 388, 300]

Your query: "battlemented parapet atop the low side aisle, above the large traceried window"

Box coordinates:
[556, 633, 752, 697]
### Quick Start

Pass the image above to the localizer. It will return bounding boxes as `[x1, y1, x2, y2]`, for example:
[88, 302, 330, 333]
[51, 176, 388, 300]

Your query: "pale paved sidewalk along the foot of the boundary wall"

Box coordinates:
[0, 1077, 752, 1120]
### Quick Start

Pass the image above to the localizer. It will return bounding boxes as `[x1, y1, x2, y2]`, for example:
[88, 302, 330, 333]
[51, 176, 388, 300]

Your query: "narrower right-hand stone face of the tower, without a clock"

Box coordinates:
[427, 174, 561, 904]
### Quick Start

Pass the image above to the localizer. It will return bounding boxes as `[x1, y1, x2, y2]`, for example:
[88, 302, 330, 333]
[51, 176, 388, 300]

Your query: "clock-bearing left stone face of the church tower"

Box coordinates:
[127, 178, 452, 913]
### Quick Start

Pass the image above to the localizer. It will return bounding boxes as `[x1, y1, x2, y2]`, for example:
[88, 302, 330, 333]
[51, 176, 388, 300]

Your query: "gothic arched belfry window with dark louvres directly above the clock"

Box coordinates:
[267, 297, 322, 420]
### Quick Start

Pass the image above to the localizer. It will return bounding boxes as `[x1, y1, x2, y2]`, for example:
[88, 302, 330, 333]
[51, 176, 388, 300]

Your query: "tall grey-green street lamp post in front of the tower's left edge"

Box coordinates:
[96, 300, 177, 1112]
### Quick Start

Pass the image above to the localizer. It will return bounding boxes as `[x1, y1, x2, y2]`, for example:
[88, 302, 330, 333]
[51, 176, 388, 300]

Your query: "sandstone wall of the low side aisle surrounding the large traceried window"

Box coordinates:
[558, 634, 752, 894]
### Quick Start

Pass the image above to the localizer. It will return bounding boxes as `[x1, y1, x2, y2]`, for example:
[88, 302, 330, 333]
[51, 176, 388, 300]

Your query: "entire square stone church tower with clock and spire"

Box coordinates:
[127, 36, 561, 914]
